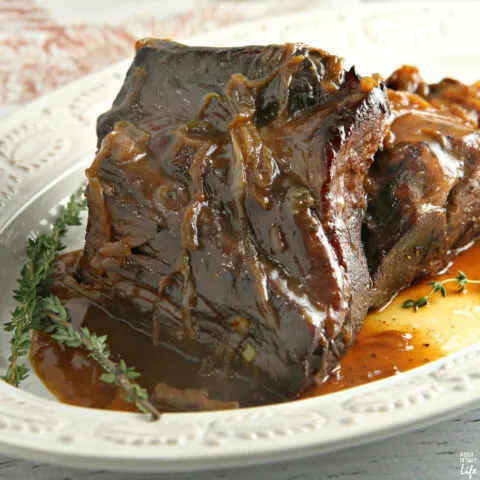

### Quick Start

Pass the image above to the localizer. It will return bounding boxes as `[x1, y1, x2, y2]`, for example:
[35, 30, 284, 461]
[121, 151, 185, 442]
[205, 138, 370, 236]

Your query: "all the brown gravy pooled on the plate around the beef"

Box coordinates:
[30, 243, 480, 411]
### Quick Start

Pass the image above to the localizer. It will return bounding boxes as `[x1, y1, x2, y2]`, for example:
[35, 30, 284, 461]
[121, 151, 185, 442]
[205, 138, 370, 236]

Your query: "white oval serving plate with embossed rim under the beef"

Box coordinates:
[0, 2, 480, 471]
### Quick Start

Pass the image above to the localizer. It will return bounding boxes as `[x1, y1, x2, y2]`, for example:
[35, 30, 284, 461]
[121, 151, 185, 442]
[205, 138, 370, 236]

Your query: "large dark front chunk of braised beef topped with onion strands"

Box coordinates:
[77, 39, 389, 403]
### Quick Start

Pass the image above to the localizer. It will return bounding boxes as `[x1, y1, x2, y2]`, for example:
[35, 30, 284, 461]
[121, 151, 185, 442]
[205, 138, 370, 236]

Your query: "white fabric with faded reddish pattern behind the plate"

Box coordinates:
[0, 0, 331, 114]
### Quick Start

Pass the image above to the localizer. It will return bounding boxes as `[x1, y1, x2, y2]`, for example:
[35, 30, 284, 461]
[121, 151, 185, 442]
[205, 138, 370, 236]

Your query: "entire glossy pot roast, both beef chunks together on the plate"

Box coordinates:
[76, 39, 480, 408]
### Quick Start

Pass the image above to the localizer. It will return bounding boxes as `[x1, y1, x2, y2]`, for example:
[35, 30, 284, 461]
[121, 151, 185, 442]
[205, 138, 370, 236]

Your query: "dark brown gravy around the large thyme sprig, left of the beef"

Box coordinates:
[31, 298, 198, 410]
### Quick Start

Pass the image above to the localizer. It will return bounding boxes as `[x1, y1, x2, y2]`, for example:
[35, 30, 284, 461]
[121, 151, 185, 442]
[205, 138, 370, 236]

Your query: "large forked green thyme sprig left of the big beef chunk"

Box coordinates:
[2, 189, 160, 419]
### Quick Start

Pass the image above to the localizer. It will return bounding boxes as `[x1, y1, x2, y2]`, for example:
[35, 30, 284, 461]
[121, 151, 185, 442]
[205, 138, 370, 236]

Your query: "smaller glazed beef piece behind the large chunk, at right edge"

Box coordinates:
[364, 78, 480, 307]
